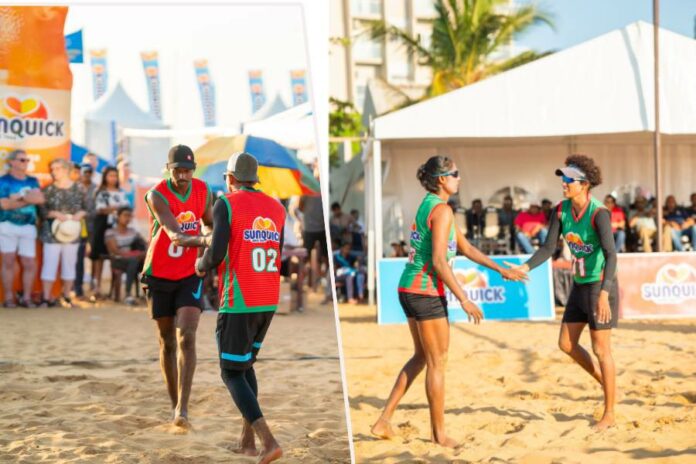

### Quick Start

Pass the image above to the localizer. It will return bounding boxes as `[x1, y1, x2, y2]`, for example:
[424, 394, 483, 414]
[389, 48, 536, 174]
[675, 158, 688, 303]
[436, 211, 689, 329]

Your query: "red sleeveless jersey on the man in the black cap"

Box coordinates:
[143, 179, 211, 280]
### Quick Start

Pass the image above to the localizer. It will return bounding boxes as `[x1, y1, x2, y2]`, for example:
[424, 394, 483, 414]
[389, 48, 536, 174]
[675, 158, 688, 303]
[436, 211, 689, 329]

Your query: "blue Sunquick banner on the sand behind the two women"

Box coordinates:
[377, 255, 554, 324]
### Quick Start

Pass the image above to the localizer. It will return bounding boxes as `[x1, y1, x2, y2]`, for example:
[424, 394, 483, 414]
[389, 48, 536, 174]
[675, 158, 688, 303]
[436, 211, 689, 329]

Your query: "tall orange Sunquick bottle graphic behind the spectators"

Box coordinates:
[0, 6, 72, 185]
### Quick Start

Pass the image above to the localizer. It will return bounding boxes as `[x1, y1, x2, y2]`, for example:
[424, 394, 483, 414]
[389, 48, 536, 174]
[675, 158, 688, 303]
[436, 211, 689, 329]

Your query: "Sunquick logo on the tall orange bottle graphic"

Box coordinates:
[0, 95, 65, 139]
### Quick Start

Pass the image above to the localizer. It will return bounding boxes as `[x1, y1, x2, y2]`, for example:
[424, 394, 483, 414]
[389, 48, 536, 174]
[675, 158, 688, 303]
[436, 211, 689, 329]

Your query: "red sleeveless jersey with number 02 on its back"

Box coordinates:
[218, 188, 285, 313]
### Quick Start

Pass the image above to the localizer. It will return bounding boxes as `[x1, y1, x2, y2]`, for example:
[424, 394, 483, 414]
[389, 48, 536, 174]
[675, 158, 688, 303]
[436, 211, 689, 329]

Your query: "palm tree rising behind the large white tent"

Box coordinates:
[368, 0, 553, 97]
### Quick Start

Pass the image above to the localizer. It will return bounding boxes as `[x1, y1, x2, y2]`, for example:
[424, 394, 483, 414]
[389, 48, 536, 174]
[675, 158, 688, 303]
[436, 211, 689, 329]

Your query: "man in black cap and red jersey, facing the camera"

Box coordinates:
[142, 145, 213, 428]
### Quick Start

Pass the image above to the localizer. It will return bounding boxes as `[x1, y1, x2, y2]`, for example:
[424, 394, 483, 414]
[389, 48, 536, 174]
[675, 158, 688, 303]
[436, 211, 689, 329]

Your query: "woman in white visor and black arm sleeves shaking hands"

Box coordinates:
[506, 155, 618, 430]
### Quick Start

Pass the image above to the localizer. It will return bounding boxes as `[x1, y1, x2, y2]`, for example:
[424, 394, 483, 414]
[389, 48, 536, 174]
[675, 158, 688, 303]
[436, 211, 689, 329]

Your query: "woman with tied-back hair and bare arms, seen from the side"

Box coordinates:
[372, 156, 526, 447]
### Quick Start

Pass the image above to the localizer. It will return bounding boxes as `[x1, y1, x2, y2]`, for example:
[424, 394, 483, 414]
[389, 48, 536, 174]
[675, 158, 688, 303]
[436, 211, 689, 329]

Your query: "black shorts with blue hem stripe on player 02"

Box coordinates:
[215, 311, 275, 370]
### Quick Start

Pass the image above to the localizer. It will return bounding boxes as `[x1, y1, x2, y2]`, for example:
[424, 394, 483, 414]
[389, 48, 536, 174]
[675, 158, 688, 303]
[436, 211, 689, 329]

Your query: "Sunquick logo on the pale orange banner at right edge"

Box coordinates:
[640, 263, 696, 304]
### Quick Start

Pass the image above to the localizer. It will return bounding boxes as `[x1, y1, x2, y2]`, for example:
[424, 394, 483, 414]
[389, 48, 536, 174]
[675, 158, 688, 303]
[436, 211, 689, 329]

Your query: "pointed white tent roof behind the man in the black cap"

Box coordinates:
[85, 82, 167, 129]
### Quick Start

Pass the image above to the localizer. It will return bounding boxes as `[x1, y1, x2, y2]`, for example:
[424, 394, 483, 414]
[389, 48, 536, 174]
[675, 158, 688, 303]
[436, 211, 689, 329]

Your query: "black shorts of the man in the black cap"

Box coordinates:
[141, 274, 203, 319]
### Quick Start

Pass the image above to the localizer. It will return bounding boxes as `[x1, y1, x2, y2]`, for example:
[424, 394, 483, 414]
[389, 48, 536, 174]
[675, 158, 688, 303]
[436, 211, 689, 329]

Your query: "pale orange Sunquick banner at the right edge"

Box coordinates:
[617, 252, 696, 319]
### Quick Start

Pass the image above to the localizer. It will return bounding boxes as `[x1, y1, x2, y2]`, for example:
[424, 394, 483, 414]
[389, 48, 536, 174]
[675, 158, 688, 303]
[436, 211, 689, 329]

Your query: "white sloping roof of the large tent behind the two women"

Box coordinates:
[374, 21, 696, 139]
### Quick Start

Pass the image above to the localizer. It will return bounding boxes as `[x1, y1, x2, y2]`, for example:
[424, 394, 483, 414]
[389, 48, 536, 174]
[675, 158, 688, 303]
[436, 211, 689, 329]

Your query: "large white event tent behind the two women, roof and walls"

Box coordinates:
[365, 22, 696, 266]
